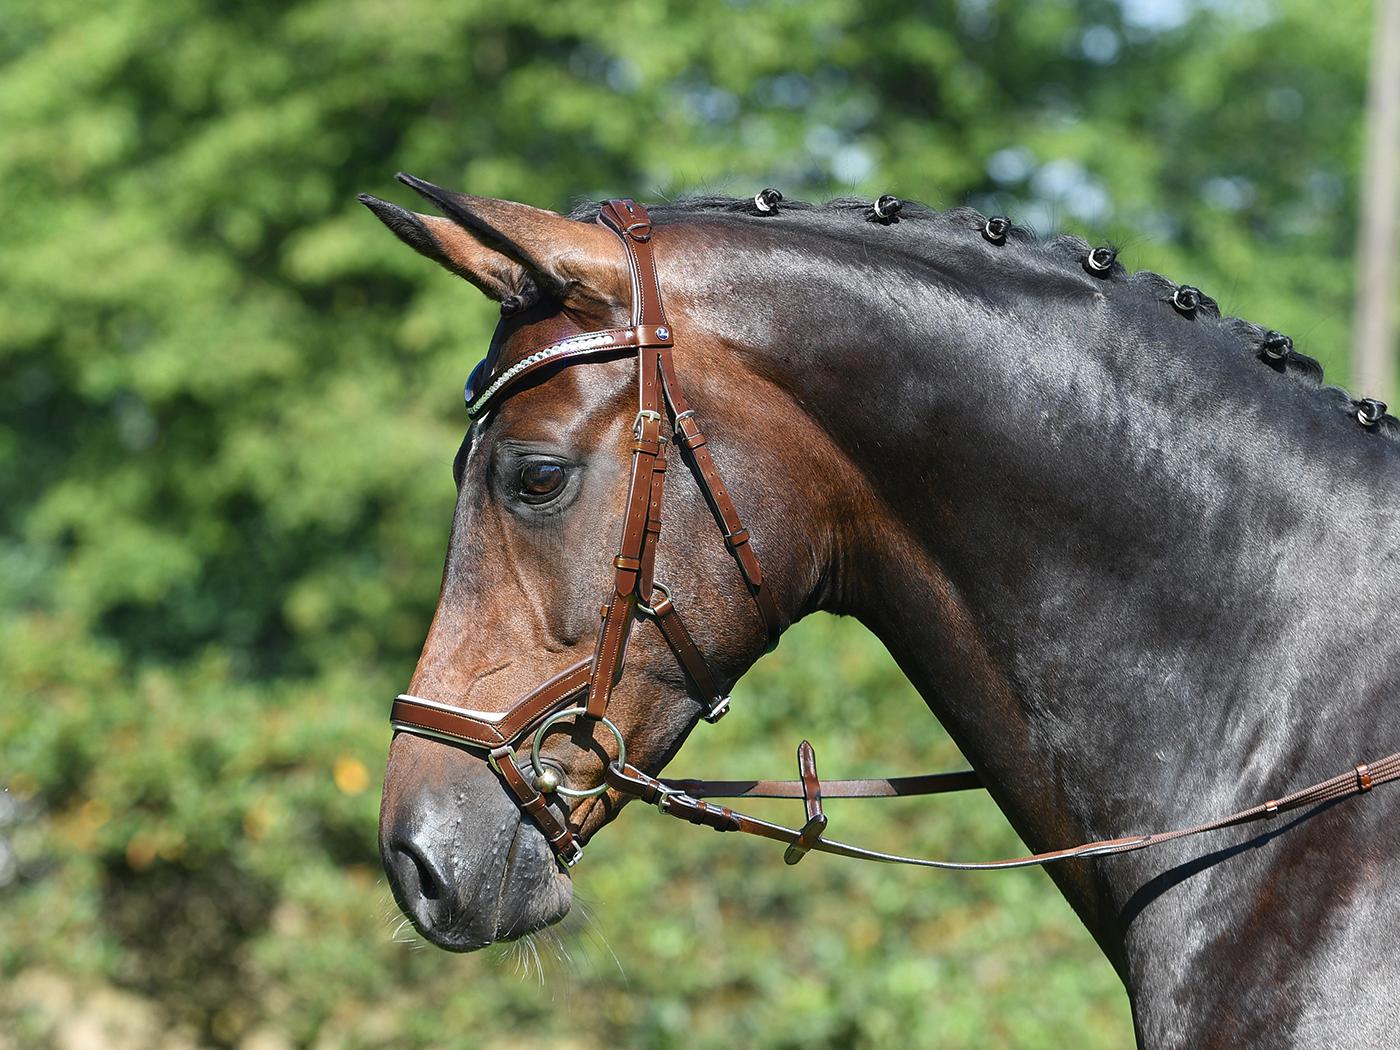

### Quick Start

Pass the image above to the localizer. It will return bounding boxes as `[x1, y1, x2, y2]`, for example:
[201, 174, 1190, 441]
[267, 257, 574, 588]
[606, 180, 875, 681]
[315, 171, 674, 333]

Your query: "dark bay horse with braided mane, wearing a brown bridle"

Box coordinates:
[361, 175, 1400, 1047]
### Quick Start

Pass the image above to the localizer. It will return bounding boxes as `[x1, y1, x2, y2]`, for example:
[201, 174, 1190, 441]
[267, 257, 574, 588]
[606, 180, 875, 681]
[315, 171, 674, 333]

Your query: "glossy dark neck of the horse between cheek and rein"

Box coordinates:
[711, 232, 1400, 879]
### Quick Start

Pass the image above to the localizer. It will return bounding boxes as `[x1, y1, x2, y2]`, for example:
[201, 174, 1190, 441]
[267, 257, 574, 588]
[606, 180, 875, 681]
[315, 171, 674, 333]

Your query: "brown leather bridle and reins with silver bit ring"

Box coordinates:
[389, 200, 1400, 871]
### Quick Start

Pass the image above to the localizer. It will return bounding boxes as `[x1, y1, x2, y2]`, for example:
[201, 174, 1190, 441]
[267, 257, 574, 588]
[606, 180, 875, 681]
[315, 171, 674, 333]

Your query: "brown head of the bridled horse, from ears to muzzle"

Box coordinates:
[363, 176, 844, 951]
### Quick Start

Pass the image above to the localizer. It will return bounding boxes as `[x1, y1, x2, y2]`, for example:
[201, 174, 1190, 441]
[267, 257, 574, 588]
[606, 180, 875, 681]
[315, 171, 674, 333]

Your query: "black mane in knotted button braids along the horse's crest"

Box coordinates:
[568, 195, 1400, 442]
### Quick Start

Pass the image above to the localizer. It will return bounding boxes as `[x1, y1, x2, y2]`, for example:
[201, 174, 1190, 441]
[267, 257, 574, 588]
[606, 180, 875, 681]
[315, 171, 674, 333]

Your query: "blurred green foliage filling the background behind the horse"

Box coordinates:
[0, 0, 1369, 1047]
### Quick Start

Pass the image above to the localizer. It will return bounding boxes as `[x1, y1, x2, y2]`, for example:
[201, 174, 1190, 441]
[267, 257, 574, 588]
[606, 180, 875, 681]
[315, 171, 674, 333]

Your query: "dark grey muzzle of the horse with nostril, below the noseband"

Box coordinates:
[385, 819, 574, 952]
